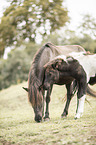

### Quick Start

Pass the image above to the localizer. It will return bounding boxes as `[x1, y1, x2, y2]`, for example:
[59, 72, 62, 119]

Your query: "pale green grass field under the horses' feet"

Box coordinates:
[0, 82, 96, 145]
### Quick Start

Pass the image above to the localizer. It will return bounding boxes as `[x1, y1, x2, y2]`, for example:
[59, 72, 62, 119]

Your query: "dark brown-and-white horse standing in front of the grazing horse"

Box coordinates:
[41, 53, 96, 119]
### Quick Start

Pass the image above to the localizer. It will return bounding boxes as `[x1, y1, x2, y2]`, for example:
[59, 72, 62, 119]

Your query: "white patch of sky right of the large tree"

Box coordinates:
[65, 0, 96, 29]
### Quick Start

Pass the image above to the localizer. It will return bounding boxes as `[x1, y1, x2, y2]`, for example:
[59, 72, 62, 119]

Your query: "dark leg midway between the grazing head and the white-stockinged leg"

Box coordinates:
[61, 83, 73, 118]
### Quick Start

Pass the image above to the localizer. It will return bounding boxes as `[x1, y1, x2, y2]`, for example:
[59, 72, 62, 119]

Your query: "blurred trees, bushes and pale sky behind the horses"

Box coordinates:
[0, 0, 96, 90]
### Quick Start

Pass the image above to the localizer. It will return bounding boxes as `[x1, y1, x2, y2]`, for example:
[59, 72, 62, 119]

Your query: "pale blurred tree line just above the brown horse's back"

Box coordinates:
[44, 29, 96, 53]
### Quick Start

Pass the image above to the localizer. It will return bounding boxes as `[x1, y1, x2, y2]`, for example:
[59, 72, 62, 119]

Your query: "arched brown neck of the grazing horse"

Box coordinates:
[28, 43, 60, 86]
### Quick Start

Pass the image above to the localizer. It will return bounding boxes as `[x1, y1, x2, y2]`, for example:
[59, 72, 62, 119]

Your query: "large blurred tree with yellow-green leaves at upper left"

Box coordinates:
[0, 0, 69, 55]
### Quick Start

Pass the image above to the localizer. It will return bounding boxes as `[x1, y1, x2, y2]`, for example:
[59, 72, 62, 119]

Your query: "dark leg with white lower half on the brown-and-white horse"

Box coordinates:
[75, 78, 87, 119]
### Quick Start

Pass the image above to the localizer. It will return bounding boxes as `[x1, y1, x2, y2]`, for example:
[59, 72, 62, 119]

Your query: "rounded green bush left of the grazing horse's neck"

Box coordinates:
[0, 50, 32, 90]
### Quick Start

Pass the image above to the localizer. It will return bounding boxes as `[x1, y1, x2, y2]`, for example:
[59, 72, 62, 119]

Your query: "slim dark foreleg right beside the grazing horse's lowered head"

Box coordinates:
[44, 85, 53, 121]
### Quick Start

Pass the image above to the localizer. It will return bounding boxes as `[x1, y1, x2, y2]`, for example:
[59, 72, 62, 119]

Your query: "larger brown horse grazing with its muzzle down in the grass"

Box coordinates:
[25, 43, 96, 122]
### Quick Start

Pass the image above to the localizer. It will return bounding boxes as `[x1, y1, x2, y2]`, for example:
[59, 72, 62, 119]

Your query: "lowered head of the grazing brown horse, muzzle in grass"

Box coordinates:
[23, 82, 44, 122]
